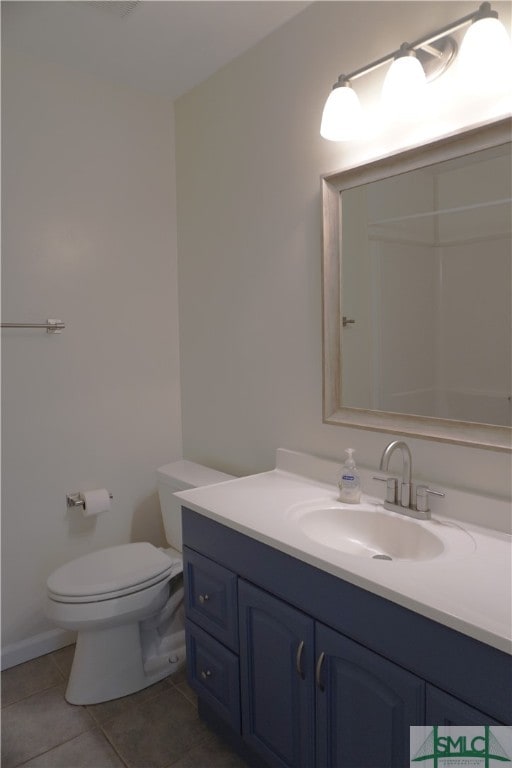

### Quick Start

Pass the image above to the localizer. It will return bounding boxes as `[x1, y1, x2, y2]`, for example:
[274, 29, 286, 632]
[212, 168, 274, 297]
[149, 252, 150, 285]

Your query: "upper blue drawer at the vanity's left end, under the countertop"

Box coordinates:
[183, 547, 238, 653]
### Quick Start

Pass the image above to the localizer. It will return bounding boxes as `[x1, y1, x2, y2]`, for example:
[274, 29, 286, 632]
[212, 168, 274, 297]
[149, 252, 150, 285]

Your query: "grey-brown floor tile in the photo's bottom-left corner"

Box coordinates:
[2, 685, 93, 768]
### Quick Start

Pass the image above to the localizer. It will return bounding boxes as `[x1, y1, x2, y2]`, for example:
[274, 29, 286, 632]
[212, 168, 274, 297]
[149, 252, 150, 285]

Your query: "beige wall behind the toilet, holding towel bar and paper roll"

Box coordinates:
[2, 51, 181, 651]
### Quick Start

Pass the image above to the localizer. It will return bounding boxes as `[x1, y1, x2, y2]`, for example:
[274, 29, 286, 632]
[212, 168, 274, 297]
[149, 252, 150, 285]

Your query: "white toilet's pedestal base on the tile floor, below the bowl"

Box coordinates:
[65, 621, 185, 704]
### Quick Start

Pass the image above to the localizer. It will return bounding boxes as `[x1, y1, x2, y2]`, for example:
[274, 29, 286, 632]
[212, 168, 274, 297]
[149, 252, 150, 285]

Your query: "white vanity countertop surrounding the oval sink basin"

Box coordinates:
[176, 452, 512, 654]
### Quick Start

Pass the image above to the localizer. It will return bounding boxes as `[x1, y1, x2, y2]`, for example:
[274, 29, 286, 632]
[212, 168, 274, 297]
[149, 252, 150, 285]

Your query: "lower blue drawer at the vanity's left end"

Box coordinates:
[186, 621, 240, 733]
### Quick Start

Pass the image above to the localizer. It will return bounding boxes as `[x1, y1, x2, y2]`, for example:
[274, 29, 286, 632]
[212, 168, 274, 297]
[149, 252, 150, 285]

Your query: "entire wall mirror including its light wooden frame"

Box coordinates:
[322, 119, 512, 450]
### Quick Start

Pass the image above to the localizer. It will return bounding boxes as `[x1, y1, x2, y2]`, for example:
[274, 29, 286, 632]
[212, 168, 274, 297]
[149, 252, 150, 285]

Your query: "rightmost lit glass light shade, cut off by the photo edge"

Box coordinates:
[458, 17, 512, 91]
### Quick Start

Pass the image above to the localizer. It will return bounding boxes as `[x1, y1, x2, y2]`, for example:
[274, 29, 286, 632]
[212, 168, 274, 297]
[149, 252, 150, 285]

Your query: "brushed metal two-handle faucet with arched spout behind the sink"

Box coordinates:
[374, 440, 444, 520]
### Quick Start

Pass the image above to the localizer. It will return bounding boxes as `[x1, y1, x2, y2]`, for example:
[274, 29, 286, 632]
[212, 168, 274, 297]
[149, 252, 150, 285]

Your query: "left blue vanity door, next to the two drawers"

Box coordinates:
[238, 579, 315, 768]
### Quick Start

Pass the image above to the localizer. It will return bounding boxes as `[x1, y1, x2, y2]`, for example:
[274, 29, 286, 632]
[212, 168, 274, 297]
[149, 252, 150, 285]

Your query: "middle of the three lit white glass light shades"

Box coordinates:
[382, 56, 427, 120]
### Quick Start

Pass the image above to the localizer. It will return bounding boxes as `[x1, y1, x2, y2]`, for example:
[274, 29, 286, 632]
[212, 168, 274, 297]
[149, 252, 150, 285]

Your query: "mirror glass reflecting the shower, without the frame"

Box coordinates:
[341, 144, 512, 426]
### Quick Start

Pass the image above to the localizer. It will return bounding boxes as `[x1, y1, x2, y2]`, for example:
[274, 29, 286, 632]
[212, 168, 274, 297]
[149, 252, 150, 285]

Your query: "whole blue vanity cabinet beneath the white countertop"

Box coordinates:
[182, 508, 512, 768]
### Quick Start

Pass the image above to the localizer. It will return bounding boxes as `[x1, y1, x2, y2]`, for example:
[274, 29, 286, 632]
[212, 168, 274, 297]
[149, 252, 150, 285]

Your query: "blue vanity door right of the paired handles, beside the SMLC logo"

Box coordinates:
[316, 624, 425, 768]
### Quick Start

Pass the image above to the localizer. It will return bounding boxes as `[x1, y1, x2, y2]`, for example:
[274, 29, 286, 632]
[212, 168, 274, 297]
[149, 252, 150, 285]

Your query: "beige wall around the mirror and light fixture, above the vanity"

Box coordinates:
[176, 2, 510, 488]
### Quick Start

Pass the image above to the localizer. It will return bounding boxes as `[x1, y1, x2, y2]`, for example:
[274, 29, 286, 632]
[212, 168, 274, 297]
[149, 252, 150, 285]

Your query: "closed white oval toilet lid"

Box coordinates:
[47, 542, 174, 601]
